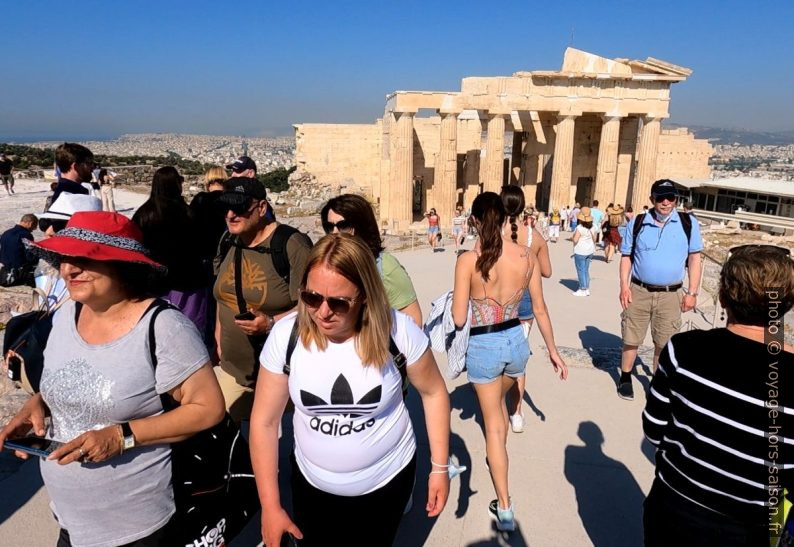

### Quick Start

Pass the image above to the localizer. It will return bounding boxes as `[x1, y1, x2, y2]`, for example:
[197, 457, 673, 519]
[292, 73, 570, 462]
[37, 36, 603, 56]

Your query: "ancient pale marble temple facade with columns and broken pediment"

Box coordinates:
[295, 48, 712, 230]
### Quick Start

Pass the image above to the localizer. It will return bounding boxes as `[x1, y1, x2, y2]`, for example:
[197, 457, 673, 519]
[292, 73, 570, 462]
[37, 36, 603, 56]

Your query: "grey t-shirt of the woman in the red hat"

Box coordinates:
[41, 302, 209, 547]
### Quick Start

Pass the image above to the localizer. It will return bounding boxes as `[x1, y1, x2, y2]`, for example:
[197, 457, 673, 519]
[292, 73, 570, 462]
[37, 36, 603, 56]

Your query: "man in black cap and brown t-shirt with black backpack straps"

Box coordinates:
[214, 177, 311, 423]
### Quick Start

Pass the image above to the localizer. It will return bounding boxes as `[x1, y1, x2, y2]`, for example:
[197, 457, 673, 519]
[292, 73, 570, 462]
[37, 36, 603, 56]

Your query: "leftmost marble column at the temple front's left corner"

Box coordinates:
[389, 112, 414, 230]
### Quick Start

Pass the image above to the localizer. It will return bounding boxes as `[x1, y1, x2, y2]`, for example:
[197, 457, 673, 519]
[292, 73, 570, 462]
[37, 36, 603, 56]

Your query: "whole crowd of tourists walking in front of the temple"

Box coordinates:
[0, 143, 794, 547]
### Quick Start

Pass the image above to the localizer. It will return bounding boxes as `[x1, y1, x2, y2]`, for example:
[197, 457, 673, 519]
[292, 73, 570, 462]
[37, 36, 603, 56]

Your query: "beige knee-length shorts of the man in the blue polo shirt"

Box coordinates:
[620, 283, 683, 348]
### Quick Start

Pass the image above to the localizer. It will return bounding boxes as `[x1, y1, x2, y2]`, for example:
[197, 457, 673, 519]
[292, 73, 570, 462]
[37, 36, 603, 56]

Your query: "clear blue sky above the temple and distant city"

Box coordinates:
[0, 0, 794, 140]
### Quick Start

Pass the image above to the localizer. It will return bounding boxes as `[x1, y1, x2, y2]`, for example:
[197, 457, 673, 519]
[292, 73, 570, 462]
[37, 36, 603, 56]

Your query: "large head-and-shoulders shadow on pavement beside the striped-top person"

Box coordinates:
[565, 422, 645, 547]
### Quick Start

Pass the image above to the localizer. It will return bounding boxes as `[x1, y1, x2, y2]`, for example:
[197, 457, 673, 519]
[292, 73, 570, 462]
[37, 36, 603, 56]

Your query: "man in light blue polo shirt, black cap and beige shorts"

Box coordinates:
[618, 179, 703, 400]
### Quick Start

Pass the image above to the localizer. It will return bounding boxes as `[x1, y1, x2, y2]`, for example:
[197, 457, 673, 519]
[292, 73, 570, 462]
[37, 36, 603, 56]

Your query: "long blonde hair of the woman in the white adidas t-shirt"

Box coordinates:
[298, 234, 392, 368]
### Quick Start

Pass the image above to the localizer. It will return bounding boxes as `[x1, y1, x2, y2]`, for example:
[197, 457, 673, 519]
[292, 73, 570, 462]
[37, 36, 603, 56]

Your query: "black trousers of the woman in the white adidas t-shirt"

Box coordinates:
[290, 454, 416, 547]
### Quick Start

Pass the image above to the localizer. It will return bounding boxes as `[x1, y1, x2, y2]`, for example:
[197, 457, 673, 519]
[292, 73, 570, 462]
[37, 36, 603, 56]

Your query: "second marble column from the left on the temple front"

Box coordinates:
[429, 112, 458, 226]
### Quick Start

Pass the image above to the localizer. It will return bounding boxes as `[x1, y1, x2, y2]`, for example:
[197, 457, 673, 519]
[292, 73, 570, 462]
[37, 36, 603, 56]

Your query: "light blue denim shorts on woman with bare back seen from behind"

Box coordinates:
[466, 325, 530, 384]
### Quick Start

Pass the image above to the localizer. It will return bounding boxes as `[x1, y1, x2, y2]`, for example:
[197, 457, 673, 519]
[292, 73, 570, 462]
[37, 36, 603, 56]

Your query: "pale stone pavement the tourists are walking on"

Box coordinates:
[0, 189, 668, 547]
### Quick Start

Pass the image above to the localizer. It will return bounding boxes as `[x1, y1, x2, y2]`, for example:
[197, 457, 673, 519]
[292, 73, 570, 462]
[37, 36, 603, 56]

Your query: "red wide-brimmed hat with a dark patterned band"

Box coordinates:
[25, 211, 166, 271]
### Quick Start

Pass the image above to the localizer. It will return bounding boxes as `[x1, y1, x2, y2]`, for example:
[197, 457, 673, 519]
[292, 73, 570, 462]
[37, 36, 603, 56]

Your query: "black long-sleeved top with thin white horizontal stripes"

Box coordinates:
[642, 329, 794, 523]
